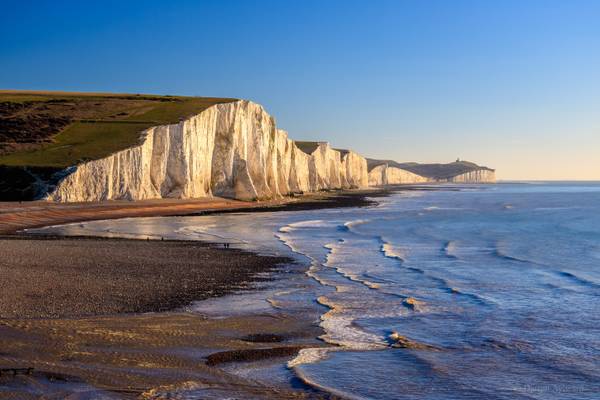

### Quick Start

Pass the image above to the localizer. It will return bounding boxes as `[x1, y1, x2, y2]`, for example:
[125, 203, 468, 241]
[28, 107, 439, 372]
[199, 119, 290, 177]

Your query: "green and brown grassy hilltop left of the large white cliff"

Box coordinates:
[0, 90, 236, 168]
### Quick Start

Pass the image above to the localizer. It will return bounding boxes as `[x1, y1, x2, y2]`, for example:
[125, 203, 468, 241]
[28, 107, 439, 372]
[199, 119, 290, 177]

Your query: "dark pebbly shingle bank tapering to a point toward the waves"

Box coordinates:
[0, 237, 290, 318]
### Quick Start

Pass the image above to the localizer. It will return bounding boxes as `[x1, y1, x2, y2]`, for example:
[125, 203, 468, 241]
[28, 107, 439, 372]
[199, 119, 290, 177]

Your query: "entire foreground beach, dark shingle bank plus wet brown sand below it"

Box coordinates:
[0, 237, 324, 399]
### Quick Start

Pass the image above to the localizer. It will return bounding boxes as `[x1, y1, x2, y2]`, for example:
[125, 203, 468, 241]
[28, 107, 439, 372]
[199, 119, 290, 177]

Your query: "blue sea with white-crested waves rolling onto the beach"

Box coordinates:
[32, 182, 600, 399]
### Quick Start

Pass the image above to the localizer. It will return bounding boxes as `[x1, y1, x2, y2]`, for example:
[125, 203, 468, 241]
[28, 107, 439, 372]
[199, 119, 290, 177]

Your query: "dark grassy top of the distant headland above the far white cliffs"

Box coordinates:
[367, 158, 494, 180]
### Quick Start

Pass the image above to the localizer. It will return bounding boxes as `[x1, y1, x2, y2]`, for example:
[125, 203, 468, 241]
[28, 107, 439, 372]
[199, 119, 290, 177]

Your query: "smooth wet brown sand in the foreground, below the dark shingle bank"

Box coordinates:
[0, 313, 327, 399]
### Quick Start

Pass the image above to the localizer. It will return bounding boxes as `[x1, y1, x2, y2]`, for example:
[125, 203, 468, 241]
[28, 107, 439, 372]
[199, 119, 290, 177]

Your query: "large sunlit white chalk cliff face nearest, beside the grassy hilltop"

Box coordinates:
[46, 100, 369, 202]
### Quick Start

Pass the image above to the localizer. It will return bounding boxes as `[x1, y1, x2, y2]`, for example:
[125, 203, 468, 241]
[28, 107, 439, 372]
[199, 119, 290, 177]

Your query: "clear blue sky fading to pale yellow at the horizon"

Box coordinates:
[0, 0, 600, 180]
